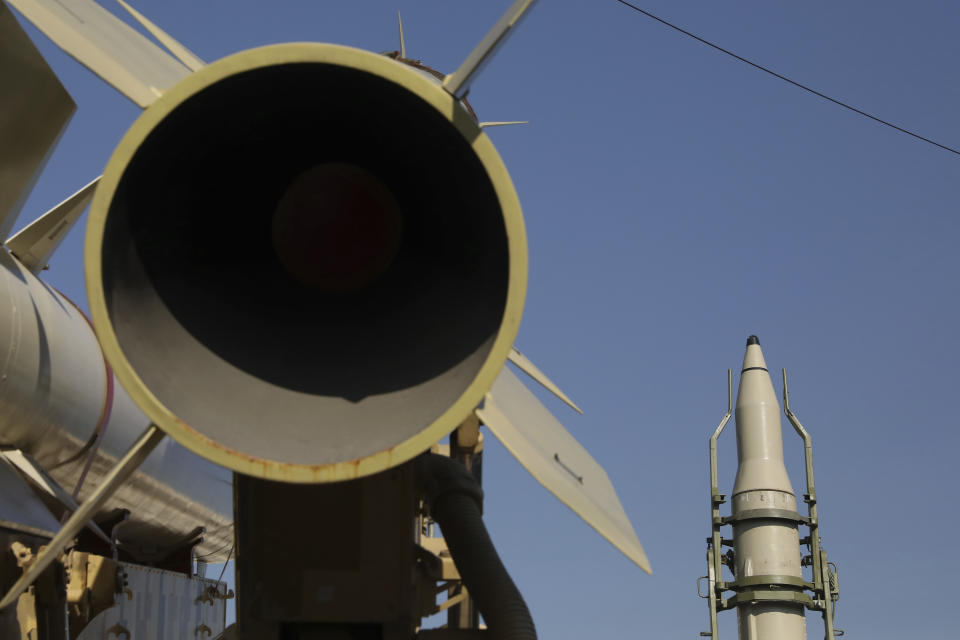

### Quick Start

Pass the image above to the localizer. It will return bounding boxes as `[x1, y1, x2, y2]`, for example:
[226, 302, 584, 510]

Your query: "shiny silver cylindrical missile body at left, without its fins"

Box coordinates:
[0, 249, 233, 562]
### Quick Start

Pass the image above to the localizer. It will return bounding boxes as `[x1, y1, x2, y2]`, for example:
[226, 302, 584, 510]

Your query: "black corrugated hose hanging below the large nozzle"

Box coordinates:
[417, 454, 537, 640]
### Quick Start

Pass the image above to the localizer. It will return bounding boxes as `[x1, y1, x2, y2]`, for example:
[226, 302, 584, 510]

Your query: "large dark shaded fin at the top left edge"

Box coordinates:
[0, 1, 77, 238]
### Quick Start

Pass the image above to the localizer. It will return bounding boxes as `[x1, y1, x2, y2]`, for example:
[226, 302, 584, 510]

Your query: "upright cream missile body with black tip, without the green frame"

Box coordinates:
[732, 336, 806, 640]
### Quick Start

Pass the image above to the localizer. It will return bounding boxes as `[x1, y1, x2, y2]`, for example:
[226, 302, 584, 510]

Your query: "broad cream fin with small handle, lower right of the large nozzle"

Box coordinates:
[477, 368, 650, 573]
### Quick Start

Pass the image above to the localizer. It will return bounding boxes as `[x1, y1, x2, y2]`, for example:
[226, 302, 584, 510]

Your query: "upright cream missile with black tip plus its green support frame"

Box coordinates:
[698, 336, 842, 640]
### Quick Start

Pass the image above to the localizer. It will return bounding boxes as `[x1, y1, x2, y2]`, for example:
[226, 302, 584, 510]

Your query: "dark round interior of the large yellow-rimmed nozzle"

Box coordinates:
[102, 63, 510, 463]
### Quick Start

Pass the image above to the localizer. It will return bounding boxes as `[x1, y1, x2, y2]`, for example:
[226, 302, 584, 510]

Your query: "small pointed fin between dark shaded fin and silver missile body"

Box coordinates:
[5, 176, 100, 273]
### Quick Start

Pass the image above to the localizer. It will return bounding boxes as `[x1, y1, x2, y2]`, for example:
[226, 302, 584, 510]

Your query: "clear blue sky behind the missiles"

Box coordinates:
[9, 0, 960, 640]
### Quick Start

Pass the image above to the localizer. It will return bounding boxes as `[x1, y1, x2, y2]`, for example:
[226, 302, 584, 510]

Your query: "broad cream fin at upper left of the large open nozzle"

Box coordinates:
[9, 0, 191, 108]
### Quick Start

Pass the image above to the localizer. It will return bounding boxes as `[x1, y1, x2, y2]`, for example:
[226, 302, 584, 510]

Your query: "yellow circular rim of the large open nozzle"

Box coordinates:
[85, 43, 527, 483]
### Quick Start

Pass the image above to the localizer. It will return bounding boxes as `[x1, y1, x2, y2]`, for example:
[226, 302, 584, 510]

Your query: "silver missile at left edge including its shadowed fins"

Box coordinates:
[0, 2, 233, 564]
